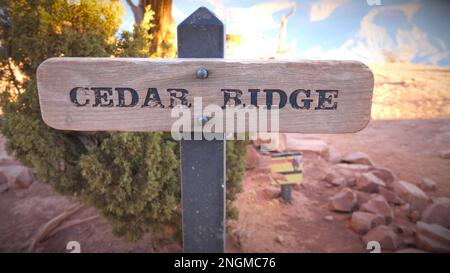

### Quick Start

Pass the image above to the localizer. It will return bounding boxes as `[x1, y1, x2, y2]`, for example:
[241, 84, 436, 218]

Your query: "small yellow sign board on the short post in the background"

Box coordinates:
[271, 152, 303, 185]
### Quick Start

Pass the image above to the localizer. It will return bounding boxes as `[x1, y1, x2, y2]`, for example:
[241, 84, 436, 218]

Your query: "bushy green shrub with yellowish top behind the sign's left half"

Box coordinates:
[0, 0, 246, 240]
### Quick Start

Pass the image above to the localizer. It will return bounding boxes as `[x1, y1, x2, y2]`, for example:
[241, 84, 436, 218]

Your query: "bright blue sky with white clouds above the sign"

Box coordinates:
[121, 0, 450, 67]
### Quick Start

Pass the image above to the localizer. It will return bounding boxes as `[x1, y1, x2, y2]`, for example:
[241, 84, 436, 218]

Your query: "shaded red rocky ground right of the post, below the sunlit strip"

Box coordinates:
[233, 124, 450, 252]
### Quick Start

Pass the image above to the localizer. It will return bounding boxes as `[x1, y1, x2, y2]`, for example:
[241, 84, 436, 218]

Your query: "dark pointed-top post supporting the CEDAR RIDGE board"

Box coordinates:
[177, 7, 226, 253]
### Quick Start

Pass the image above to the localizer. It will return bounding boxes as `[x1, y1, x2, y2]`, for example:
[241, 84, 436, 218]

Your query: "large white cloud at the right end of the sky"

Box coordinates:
[301, 2, 449, 65]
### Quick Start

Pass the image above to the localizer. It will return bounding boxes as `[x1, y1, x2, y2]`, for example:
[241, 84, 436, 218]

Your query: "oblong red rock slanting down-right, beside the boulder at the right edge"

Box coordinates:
[393, 181, 430, 212]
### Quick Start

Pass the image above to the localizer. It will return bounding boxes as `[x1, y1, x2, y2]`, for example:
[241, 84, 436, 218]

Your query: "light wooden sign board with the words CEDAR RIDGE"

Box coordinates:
[37, 58, 373, 133]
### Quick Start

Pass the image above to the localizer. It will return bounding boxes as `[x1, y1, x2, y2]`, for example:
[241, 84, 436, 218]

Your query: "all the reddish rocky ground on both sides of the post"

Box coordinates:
[0, 64, 450, 252]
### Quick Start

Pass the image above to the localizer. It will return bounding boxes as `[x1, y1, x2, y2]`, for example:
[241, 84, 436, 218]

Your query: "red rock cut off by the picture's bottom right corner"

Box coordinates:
[416, 222, 450, 252]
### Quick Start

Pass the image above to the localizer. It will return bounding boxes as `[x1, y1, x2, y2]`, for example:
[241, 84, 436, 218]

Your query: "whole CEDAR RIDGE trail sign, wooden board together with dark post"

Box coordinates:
[37, 5, 373, 252]
